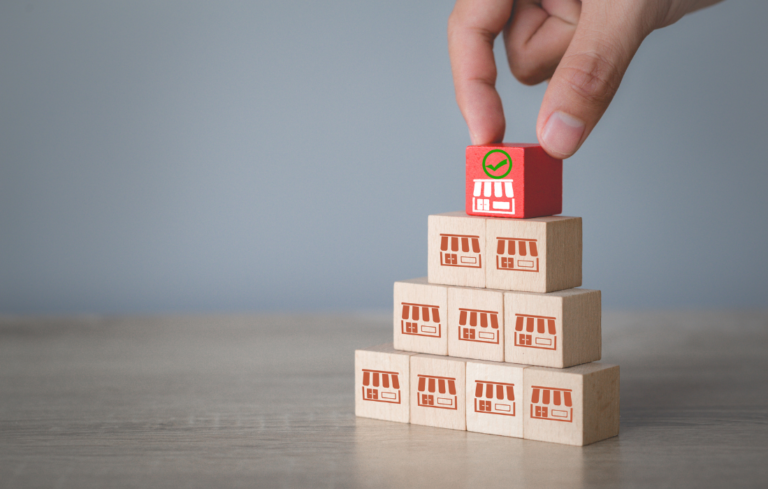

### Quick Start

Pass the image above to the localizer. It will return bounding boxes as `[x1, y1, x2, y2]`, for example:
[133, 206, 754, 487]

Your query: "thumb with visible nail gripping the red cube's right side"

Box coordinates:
[536, 0, 650, 158]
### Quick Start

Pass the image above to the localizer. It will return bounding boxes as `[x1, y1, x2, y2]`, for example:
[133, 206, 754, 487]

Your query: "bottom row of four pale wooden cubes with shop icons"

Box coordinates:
[355, 343, 619, 446]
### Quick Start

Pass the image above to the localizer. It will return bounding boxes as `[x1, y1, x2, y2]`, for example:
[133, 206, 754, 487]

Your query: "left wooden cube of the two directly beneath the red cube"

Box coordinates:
[427, 212, 485, 287]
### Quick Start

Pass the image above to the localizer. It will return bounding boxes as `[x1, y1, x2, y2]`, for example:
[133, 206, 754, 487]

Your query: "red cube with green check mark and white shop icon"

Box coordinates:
[466, 143, 563, 218]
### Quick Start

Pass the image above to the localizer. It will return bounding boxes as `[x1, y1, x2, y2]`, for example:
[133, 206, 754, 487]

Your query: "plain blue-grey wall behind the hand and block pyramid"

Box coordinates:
[0, 0, 768, 313]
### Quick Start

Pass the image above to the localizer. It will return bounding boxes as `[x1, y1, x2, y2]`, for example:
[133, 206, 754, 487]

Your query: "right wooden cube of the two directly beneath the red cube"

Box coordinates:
[485, 217, 581, 292]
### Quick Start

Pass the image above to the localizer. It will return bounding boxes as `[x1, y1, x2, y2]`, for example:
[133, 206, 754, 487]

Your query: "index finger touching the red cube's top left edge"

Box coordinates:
[448, 0, 514, 144]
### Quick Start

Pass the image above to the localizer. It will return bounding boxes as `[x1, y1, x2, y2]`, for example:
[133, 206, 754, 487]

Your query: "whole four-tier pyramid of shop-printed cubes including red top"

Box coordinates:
[355, 144, 619, 446]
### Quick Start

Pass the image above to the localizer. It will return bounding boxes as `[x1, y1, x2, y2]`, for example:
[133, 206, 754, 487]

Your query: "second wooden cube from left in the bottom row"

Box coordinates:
[411, 354, 467, 430]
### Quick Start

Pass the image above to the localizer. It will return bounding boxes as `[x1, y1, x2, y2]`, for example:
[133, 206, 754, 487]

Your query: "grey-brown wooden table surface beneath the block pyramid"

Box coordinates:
[0, 312, 768, 489]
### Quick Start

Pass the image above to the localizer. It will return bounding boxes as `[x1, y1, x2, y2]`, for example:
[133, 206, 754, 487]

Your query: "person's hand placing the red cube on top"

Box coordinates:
[448, 0, 720, 158]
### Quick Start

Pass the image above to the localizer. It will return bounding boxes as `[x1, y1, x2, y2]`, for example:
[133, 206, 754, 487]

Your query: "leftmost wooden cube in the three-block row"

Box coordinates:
[394, 277, 448, 355]
